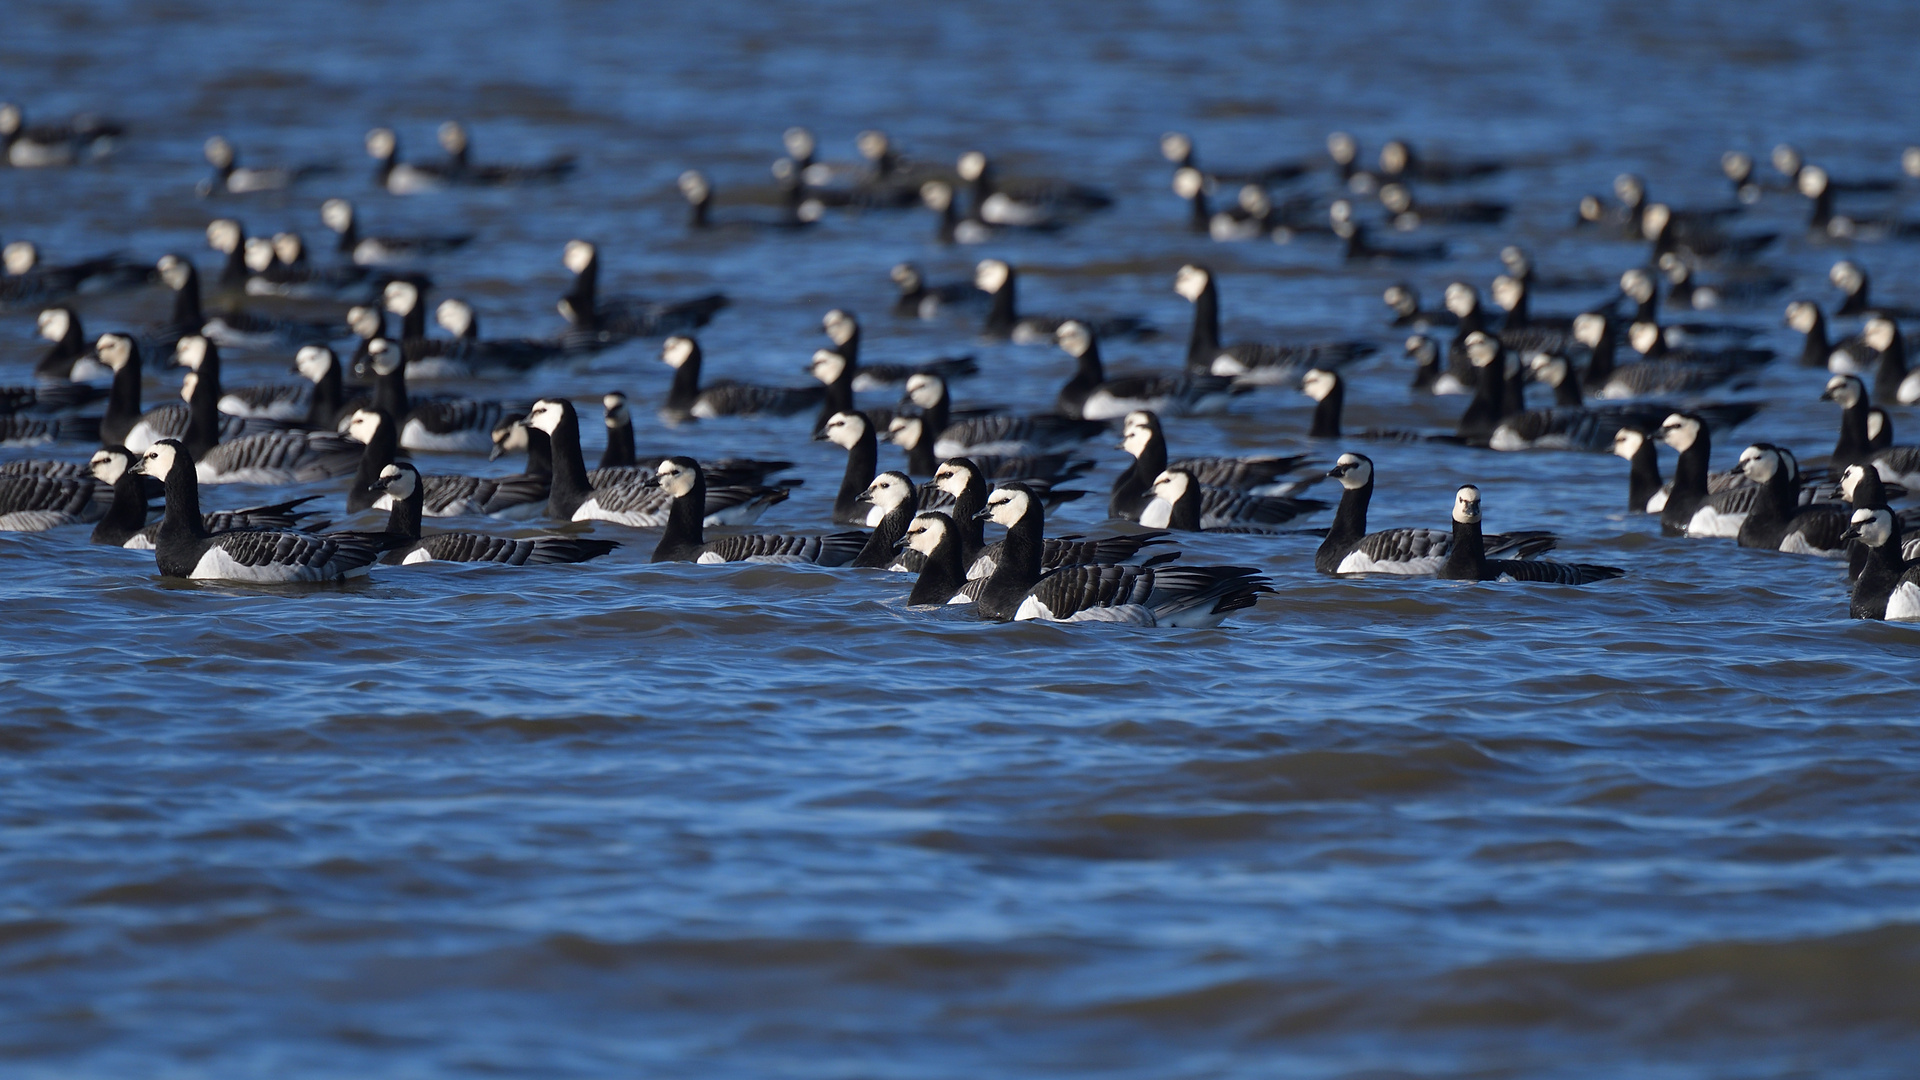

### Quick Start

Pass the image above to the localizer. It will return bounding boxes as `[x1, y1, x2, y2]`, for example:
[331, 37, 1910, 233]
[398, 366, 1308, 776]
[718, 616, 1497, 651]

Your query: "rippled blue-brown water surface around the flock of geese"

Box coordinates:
[0, 0, 1920, 1078]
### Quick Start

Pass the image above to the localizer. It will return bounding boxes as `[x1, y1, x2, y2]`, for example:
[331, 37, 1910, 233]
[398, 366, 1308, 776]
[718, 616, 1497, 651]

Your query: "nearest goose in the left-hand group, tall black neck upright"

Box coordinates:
[134, 438, 380, 584]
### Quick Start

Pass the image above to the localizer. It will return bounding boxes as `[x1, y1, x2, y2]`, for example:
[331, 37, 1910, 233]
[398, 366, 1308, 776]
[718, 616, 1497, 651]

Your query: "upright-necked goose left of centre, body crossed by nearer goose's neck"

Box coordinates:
[526, 398, 789, 528]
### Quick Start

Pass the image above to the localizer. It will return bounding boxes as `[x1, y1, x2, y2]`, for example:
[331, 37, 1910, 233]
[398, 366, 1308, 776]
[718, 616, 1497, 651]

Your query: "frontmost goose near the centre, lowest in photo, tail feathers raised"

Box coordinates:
[973, 482, 1273, 626]
